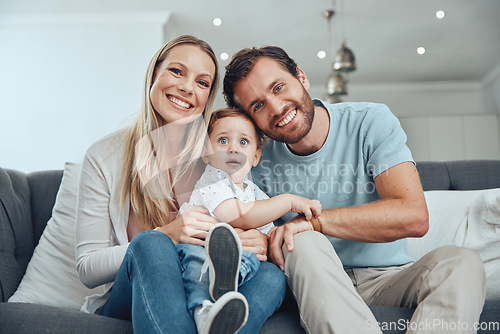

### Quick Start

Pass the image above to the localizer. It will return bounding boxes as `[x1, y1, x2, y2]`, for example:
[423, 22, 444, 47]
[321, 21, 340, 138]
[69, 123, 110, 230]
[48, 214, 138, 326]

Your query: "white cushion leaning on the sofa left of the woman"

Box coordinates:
[9, 163, 103, 310]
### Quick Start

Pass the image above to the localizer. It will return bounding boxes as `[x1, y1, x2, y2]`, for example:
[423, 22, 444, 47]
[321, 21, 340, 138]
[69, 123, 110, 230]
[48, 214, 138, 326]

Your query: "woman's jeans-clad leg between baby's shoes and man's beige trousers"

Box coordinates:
[238, 262, 286, 334]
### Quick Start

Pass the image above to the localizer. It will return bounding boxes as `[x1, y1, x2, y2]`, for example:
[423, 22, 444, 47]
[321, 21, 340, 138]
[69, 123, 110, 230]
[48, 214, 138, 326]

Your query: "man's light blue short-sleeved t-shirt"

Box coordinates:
[252, 100, 413, 268]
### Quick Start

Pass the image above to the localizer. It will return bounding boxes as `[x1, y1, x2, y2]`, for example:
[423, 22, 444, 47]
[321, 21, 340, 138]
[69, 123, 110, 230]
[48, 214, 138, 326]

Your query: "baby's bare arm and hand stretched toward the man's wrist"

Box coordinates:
[214, 194, 321, 230]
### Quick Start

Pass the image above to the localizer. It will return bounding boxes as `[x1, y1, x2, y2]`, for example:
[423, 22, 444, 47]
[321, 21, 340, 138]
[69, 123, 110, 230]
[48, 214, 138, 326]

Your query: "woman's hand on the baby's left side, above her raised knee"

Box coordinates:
[158, 206, 217, 246]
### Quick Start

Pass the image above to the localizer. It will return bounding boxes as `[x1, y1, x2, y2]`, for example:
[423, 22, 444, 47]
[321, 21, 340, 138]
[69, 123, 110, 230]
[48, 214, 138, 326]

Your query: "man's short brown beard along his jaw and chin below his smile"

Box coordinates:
[265, 87, 314, 144]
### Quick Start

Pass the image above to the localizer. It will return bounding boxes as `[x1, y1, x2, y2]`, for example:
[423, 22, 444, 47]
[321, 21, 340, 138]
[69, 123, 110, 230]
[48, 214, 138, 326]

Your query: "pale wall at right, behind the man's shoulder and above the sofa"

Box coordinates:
[309, 78, 500, 161]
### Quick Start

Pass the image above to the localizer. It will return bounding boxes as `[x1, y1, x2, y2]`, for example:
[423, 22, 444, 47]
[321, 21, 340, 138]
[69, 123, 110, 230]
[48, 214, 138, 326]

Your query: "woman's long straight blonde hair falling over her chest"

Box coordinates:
[121, 35, 219, 229]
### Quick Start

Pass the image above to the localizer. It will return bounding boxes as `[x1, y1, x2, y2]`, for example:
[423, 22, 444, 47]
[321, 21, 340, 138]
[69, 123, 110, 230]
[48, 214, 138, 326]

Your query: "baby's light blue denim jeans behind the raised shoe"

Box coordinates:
[175, 244, 260, 315]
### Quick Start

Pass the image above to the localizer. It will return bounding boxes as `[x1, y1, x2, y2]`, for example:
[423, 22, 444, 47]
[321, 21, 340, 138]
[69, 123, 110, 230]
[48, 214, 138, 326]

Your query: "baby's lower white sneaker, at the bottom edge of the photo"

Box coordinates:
[194, 291, 248, 334]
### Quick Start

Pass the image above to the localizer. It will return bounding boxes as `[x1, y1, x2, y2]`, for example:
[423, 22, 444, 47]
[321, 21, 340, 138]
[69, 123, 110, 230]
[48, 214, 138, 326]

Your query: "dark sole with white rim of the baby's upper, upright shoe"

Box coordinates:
[205, 224, 241, 301]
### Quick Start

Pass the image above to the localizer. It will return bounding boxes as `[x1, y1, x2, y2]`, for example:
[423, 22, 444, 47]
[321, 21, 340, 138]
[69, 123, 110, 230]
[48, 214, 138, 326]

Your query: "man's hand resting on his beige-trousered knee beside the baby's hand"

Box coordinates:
[269, 215, 313, 271]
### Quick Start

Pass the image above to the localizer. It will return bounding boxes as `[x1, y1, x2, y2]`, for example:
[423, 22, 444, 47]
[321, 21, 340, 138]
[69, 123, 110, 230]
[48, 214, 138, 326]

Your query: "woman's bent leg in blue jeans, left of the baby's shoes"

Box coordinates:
[101, 231, 196, 333]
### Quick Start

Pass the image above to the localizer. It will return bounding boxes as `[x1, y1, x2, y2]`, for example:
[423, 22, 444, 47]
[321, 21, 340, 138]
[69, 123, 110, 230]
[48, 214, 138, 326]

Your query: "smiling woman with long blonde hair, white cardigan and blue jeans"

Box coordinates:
[76, 36, 285, 333]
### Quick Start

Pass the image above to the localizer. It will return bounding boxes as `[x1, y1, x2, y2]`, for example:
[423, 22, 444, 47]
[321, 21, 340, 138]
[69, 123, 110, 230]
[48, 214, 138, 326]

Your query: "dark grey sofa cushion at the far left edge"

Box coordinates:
[0, 168, 33, 301]
